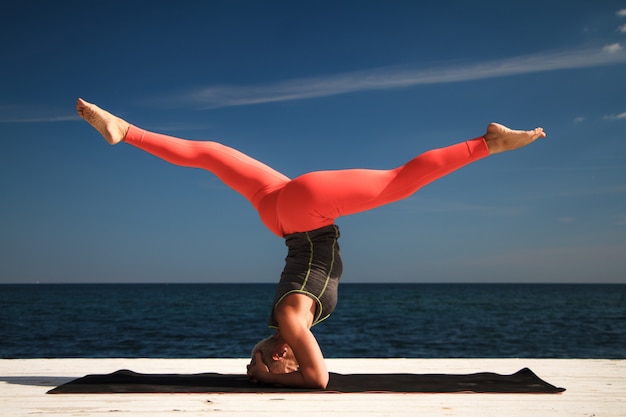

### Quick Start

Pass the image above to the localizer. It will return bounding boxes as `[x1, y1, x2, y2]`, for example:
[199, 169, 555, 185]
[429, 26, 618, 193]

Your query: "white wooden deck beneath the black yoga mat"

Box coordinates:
[0, 359, 626, 417]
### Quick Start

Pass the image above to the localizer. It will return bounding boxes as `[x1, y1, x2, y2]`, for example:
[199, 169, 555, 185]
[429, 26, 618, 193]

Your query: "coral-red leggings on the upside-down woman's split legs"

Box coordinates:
[124, 126, 489, 237]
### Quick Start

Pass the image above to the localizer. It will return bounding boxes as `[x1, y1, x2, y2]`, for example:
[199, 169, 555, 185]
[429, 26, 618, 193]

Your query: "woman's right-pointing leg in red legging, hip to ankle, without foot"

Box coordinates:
[277, 137, 489, 234]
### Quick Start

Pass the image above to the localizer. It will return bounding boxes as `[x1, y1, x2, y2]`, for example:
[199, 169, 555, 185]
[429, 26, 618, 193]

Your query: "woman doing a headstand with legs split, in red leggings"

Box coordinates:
[76, 99, 546, 388]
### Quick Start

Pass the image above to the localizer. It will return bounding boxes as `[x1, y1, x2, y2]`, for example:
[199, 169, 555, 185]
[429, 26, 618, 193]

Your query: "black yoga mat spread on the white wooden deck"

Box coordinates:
[48, 368, 565, 394]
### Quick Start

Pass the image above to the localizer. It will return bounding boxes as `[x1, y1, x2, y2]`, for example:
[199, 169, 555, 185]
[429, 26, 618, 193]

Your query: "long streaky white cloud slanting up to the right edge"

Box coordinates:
[164, 43, 626, 108]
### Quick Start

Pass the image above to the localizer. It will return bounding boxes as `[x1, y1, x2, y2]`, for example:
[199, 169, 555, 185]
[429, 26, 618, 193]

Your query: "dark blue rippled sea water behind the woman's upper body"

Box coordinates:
[0, 284, 626, 358]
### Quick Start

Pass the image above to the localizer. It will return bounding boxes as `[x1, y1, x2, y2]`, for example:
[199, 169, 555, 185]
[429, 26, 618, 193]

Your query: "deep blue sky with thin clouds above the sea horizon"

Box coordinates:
[0, 0, 626, 283]
